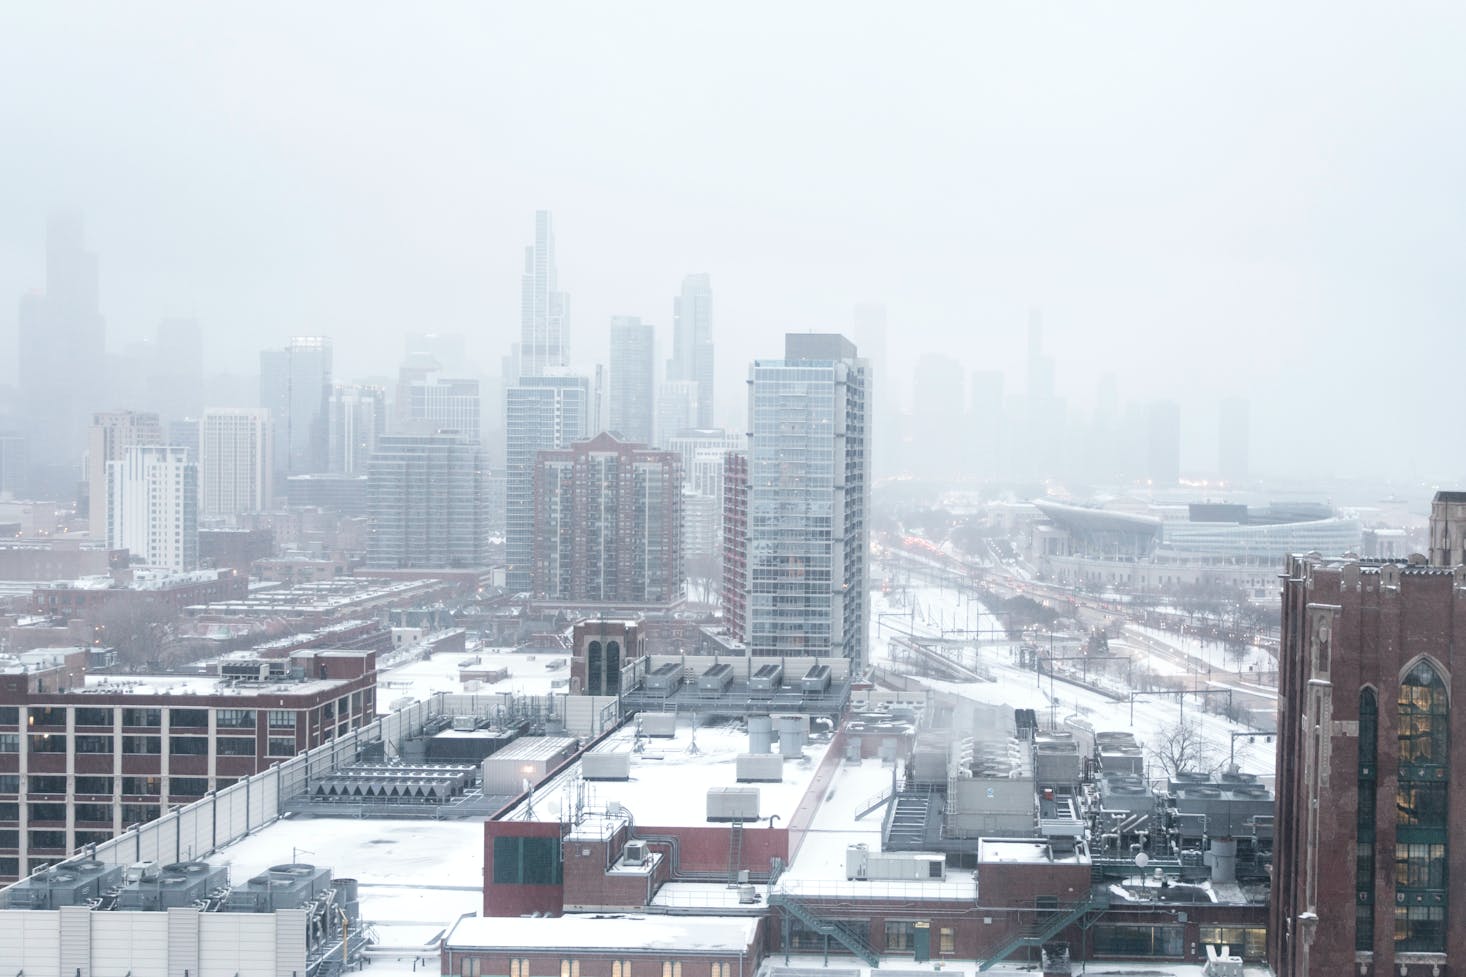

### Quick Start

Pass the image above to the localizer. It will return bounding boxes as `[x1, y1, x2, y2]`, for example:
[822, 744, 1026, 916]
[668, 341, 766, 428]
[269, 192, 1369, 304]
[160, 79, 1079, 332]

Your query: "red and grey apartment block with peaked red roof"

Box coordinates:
[534, 433, 685, 606]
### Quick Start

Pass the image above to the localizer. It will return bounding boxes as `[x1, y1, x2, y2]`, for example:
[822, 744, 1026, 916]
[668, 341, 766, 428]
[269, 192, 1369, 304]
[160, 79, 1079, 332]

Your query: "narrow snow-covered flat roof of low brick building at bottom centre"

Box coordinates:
[446, 912, 758, 954]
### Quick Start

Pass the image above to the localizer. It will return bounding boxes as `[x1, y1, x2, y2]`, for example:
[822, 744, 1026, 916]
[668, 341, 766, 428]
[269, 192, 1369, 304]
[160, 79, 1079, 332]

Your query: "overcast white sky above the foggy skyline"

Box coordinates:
[0, 1, 1466, 477]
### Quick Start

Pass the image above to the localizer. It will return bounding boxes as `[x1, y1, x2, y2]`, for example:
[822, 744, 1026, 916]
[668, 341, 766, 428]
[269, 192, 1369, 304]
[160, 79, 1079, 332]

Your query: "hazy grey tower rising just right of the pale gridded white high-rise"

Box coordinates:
[259, 336, 331, 483]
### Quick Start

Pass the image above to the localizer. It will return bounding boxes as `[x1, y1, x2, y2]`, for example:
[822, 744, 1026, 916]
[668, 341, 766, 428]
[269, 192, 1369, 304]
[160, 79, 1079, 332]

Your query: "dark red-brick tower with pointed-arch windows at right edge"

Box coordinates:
[1268, 493, 1466, 977]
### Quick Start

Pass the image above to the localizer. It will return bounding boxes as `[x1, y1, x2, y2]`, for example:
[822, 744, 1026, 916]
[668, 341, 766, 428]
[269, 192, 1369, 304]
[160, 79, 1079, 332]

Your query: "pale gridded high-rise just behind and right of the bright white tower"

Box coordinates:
[198, 408, 274, 519]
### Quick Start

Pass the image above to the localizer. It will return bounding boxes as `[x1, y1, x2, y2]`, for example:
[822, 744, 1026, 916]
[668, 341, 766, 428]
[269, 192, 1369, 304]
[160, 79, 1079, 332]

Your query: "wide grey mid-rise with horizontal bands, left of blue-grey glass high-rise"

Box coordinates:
[367, 434, 488, 569]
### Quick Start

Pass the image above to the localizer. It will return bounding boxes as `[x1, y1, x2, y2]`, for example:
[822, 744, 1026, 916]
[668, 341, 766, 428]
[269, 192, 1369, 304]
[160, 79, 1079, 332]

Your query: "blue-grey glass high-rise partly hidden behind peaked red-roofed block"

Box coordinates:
[504, 377, 591, 591]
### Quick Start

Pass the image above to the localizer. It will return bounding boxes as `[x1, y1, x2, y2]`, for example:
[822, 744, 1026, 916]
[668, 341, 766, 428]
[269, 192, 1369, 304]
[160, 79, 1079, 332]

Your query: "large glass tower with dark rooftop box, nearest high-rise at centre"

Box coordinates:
[738, 333, 871, 667]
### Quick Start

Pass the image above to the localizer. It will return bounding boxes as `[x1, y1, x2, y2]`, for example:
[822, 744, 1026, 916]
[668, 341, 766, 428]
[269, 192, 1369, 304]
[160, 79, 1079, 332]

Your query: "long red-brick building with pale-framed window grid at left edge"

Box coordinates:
[0, 648, 377, 880]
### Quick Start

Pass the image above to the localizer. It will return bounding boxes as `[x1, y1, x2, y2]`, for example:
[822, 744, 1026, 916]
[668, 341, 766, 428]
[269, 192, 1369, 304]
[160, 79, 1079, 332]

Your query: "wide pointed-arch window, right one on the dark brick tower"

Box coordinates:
[1394, 660, 1450, 952]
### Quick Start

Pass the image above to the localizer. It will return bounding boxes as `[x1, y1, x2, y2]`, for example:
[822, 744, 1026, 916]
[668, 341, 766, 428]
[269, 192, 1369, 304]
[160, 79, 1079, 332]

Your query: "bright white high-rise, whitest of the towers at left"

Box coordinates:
[107, 446, 198, 571]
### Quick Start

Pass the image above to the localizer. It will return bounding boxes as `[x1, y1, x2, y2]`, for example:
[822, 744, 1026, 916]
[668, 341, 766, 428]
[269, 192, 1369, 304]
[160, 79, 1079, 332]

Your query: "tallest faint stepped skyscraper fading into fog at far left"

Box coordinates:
[16, 217, 107, 491]
